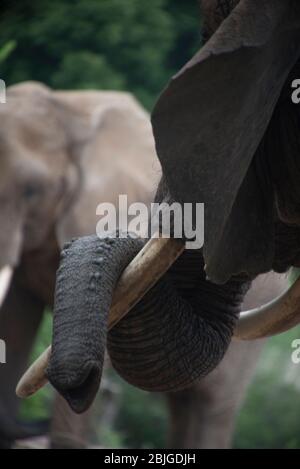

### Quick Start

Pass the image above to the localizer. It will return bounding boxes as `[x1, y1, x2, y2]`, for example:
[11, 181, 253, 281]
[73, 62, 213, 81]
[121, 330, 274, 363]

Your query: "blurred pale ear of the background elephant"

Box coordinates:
[55, 91, 160, 245]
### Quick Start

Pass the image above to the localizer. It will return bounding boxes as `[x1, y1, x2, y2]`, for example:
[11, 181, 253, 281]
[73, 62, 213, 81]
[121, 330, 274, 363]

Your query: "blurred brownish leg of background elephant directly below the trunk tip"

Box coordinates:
[51, 393, 93, 449]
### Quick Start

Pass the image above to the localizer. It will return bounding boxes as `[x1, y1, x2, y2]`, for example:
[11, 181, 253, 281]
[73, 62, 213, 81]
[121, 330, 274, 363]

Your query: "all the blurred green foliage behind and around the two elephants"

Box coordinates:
[0, 0, 300, 448]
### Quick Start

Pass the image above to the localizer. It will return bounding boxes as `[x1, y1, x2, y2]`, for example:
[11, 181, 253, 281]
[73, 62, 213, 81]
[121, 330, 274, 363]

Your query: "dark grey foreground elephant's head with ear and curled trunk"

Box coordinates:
[47, 0, 300, 412]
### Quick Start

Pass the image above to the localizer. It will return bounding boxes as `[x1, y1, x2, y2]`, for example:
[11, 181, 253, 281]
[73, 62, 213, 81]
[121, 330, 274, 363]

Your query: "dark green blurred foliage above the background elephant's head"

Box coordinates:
[0, 0, 201, 106]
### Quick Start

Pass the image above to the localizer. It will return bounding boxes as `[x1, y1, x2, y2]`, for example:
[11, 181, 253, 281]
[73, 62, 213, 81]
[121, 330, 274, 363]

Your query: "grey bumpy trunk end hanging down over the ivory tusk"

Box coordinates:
[47, 236, 142, 413]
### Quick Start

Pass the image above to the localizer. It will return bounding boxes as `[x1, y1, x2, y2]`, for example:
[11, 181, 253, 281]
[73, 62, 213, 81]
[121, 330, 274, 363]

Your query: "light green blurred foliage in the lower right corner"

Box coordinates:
[235, 327, 300, 449]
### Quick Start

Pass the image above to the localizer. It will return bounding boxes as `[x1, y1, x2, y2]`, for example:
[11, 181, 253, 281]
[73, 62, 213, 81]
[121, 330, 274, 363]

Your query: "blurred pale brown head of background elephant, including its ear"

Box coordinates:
[0, 82, 159, 306]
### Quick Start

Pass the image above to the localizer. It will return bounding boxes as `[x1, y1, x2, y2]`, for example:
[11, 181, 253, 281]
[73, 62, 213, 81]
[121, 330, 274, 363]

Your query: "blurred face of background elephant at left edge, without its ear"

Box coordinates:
[0, 82, 79, 268]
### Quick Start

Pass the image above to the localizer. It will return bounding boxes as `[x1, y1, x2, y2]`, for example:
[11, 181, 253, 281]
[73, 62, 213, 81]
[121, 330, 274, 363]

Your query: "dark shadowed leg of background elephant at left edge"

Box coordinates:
[0, 275, 44, 447]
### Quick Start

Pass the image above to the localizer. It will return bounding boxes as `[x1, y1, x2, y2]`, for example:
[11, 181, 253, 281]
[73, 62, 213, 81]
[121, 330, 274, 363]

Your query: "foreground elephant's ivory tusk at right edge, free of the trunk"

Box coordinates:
[234, 279, 300, 340]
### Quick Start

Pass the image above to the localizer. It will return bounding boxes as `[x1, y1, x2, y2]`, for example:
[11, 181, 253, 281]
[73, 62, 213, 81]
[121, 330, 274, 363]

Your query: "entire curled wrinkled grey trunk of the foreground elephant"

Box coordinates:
[47, 236, 249, 412]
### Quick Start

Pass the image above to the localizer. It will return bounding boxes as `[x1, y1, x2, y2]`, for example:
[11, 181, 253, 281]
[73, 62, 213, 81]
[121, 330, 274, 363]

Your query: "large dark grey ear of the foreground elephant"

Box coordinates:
[152, 0, 300, 283]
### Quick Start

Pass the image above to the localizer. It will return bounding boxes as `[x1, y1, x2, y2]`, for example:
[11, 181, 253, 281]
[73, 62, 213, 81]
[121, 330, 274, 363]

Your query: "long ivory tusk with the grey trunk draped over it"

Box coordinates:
[16, 236, 185, 398]
